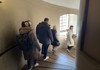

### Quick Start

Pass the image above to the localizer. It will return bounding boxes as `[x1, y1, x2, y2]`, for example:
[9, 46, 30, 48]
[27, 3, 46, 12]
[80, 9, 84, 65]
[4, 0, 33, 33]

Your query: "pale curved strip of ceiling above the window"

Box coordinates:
[43, 0, 80, 9]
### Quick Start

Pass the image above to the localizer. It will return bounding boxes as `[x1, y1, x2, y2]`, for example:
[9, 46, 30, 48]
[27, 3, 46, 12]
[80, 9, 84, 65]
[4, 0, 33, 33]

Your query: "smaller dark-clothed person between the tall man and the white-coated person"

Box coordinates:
[51, 26, 60, 53]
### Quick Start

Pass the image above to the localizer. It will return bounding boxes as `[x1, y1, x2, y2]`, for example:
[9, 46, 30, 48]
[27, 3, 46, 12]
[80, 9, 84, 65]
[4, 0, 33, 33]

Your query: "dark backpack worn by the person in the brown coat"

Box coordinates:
[17, 32, 32, 51]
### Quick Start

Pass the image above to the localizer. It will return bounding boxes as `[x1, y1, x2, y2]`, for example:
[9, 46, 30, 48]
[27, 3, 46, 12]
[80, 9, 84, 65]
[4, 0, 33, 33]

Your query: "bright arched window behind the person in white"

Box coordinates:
[60, 14, 77, 37]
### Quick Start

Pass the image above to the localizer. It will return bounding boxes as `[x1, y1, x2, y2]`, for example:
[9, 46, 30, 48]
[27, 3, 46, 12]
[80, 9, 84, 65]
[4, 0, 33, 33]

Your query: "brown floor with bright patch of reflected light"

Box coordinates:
[22, 48, 75, 70]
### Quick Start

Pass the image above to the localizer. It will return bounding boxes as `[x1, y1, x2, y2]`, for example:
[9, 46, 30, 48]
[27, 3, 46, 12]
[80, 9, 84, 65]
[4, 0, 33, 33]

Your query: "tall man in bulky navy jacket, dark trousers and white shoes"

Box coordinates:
[36, 18, 53, 61]
